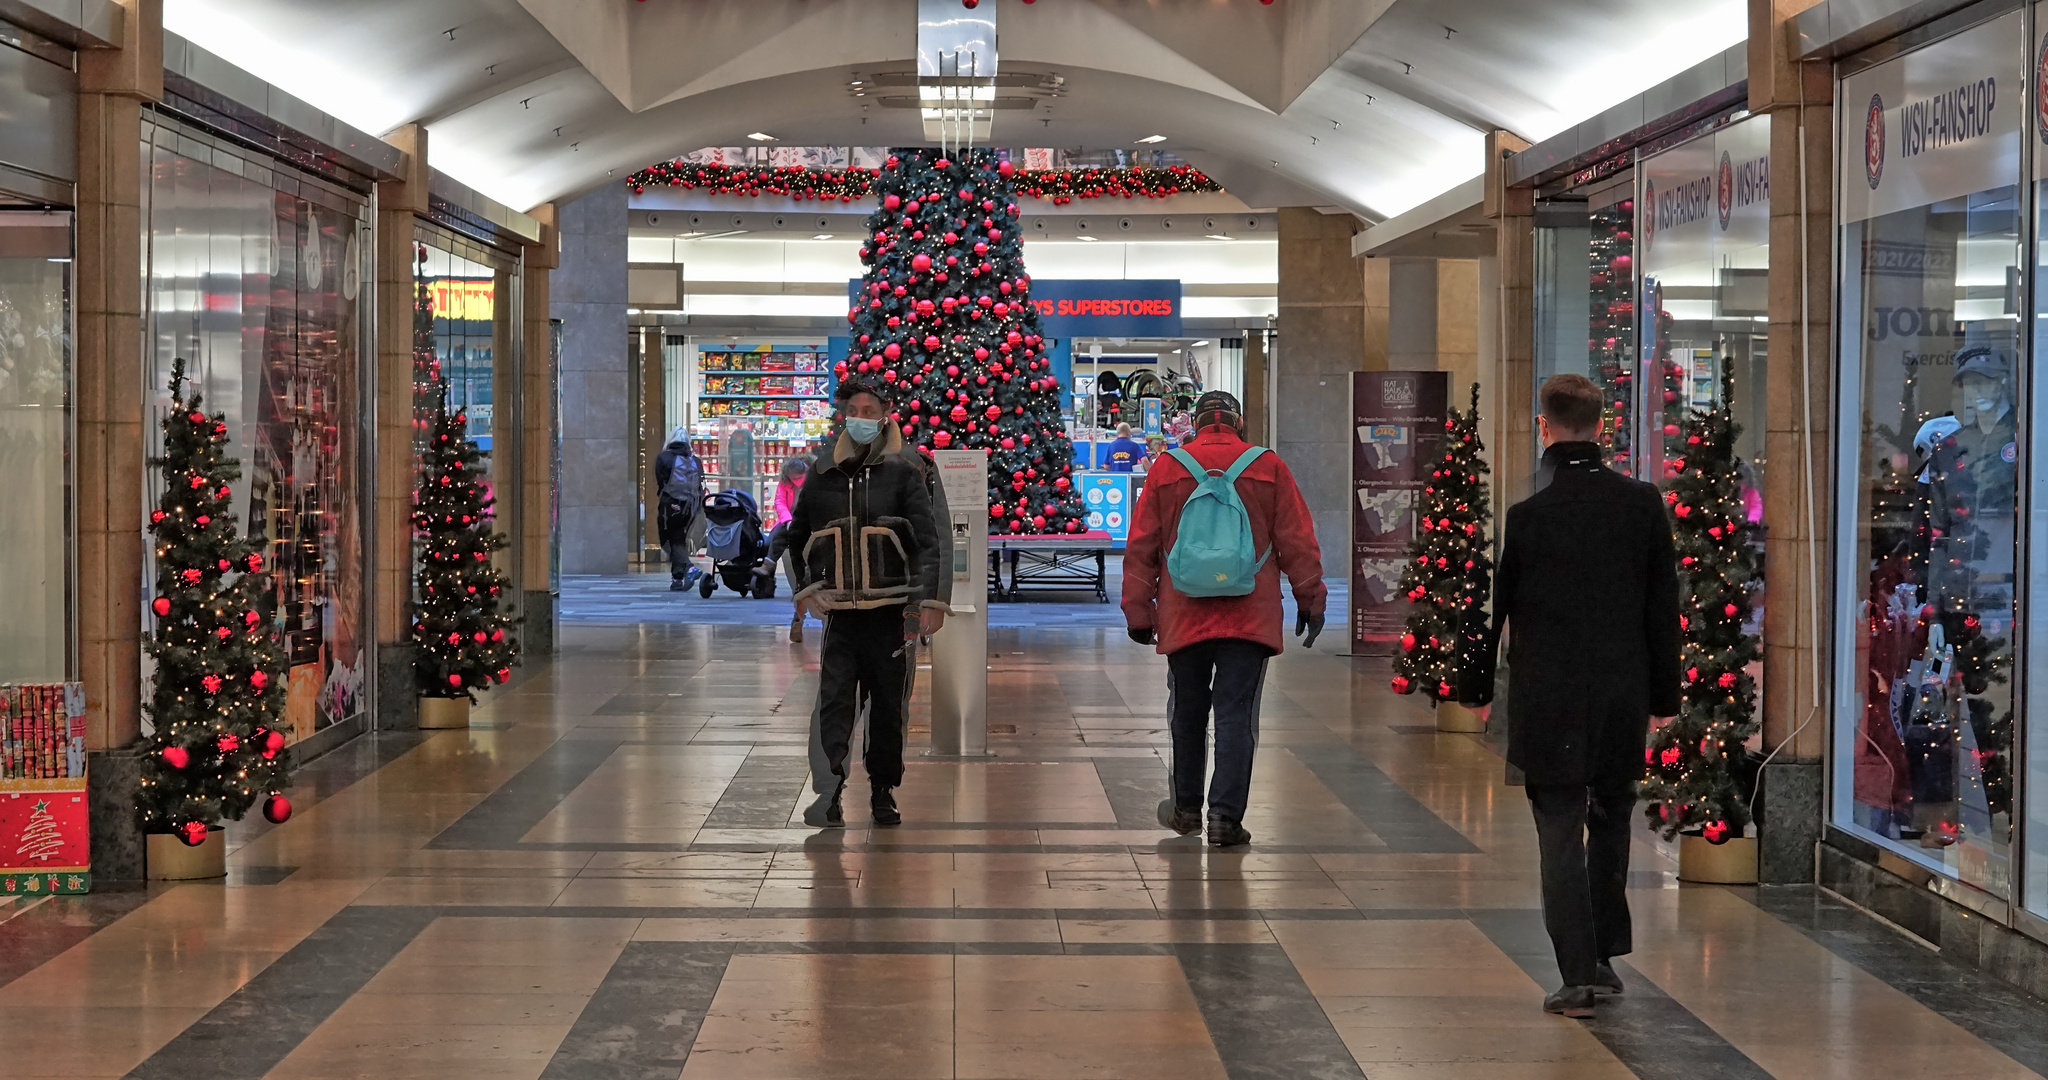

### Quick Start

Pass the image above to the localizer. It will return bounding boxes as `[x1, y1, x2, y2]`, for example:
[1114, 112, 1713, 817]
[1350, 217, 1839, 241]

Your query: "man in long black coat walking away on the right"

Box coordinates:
[1460, 375, 1679, 1016]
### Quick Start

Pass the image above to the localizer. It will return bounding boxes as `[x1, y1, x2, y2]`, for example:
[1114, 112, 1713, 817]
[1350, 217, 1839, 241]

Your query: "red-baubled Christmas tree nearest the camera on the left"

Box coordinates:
[137, 361, 291, 846]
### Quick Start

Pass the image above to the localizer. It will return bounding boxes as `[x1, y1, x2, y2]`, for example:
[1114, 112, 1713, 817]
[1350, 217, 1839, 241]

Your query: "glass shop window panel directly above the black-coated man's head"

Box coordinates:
[1536, 176, 1636, 471]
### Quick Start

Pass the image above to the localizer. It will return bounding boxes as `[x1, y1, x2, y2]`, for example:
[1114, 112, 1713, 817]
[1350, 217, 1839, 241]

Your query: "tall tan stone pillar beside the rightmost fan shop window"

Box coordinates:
[1749, 0, 1835, 883]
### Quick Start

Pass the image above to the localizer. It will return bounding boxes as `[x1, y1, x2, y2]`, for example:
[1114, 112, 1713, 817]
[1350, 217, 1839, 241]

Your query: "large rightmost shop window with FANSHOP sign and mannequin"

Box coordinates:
[1833, 12, 2025, 896]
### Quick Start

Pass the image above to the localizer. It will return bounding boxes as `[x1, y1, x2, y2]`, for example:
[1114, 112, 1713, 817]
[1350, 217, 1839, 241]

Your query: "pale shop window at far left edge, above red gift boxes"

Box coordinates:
[0, 211, 72, 682]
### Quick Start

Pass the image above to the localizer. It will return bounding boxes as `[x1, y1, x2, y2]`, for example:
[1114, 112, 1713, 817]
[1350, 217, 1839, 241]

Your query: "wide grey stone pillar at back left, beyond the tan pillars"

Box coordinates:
[549, 184, 643, 574]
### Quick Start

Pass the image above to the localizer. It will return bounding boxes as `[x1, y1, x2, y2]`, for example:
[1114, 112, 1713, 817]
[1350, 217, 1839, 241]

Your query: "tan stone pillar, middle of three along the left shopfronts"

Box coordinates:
[371, 123, 428, 730]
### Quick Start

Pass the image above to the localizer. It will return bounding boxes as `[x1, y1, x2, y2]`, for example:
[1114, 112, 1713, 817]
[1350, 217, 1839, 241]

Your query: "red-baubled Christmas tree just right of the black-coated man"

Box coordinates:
[1640, 365, 1763, 844]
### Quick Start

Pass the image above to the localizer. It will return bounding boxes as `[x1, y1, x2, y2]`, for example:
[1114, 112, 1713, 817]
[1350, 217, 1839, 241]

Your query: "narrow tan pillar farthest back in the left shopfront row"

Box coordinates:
[518, 203, 561, 656]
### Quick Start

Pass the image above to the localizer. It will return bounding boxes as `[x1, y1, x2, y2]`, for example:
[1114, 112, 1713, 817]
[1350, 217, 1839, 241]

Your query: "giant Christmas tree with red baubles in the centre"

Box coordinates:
[840, 148, 1085, 533]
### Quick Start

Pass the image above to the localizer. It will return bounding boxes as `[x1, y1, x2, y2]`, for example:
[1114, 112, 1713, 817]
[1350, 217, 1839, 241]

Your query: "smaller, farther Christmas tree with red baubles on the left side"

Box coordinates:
[412, 387, 518, 701]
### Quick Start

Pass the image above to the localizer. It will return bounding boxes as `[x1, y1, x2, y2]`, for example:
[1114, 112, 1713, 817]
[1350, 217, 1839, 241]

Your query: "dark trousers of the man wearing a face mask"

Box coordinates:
[811, 605, 918, 795]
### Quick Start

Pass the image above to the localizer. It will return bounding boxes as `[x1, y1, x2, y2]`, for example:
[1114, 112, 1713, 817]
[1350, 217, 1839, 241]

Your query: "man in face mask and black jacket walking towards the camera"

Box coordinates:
[784, 379, 946, 828]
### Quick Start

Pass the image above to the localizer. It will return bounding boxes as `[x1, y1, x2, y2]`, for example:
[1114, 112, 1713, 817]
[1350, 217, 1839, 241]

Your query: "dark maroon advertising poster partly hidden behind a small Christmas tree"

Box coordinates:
[1352, 371, 1450, 656]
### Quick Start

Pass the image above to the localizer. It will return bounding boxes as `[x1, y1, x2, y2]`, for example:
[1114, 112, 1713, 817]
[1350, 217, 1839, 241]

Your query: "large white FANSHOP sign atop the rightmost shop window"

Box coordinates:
[1835, 12, 2036, 221]
